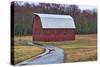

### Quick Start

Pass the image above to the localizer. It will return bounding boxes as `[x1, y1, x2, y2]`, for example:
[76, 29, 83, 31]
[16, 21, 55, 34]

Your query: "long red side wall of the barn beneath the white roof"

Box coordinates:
[38, 29, 75, 41]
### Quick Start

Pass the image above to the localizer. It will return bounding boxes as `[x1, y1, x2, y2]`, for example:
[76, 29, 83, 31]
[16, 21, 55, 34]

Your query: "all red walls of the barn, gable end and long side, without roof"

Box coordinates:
[33, 16, 75, 41]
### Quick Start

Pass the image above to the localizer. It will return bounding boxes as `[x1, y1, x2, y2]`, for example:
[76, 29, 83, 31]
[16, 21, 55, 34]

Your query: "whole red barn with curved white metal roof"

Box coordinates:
[32, 13, 75, 41]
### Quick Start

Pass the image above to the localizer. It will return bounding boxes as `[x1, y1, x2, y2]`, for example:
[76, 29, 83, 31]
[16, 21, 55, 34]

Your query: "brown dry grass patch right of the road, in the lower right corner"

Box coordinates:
[65, 49, 96, 62]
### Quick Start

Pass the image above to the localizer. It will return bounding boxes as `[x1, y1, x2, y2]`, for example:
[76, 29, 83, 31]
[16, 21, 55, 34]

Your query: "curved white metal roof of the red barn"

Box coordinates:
[34, 13, 75, 28]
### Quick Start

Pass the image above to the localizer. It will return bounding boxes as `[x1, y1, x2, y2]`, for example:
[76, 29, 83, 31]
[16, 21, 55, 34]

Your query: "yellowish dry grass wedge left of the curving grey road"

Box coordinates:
[14, 44, 44, 64]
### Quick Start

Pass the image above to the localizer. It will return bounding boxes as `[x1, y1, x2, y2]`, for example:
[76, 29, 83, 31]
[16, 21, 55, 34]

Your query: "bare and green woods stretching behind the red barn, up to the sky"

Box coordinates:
[11, 2, 97, 35]
